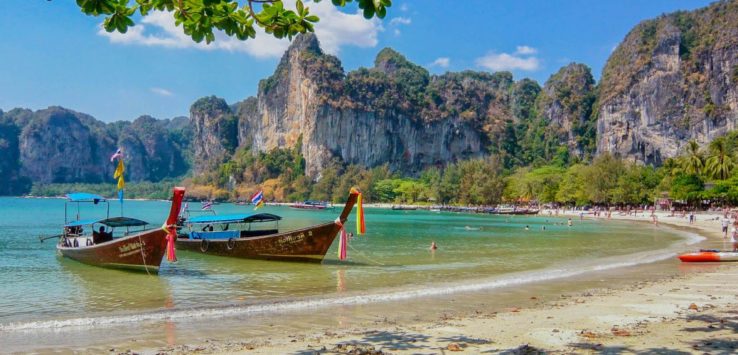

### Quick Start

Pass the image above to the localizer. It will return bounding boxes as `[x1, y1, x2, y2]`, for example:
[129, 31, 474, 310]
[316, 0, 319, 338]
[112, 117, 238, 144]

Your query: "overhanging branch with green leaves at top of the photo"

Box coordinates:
[77, 0, 392, 43]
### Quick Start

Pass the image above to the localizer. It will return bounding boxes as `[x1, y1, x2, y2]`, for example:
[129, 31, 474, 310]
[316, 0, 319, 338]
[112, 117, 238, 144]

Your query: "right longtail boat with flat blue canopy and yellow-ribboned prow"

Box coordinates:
[176, 190, 359, 262]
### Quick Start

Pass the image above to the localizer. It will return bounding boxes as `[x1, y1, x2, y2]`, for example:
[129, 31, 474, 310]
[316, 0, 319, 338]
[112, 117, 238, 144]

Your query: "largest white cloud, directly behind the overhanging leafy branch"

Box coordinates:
[98, 0, 383, 58]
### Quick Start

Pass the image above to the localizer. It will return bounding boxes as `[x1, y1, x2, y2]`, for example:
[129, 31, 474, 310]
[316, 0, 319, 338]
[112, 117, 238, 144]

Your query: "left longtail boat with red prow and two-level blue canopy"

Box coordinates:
[47, 188, 184, 273]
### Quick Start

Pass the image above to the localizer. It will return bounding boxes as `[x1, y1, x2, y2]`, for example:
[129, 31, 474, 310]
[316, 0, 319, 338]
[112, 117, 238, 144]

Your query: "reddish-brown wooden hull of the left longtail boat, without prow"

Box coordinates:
[56, 229, 166, 273]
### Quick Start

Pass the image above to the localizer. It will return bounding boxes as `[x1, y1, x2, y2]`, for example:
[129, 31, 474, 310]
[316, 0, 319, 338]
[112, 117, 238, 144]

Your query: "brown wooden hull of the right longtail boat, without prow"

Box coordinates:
[176, 223, 341, 263]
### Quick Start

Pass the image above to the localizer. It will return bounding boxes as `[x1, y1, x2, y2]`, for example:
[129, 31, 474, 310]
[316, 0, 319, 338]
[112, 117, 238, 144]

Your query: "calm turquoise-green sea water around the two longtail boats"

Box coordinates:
[0, 198, 685, 330]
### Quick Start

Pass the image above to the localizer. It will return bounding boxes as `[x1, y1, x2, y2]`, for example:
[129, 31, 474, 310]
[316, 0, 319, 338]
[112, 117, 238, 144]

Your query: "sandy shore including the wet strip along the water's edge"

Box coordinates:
[4, 211, 738, 354]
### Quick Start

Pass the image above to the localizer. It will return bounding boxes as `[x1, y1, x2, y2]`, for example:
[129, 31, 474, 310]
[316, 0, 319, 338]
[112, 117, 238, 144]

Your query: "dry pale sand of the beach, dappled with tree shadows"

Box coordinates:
[103, 211, 738, 354]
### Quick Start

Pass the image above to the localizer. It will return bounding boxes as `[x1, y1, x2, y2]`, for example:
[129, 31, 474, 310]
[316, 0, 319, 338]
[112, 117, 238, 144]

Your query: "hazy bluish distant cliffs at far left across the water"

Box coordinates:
[0, 107, 191, 189]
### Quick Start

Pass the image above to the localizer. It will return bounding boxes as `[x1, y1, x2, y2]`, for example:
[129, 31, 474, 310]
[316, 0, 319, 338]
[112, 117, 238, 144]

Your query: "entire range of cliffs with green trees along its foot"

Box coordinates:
[0, 1, 738, 205]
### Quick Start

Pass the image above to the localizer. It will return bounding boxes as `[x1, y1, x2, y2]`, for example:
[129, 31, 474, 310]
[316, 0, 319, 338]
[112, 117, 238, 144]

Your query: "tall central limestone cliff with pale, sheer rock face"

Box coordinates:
[227, 35, 515, 178]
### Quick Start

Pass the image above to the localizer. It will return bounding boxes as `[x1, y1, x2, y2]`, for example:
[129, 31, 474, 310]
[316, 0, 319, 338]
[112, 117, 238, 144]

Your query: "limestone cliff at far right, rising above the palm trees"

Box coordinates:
[596, 0, 738, 164]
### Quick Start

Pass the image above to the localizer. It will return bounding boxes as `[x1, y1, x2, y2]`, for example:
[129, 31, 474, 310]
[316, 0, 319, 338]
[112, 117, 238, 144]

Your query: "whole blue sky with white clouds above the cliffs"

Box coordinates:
[0, 0, 710, 121]
